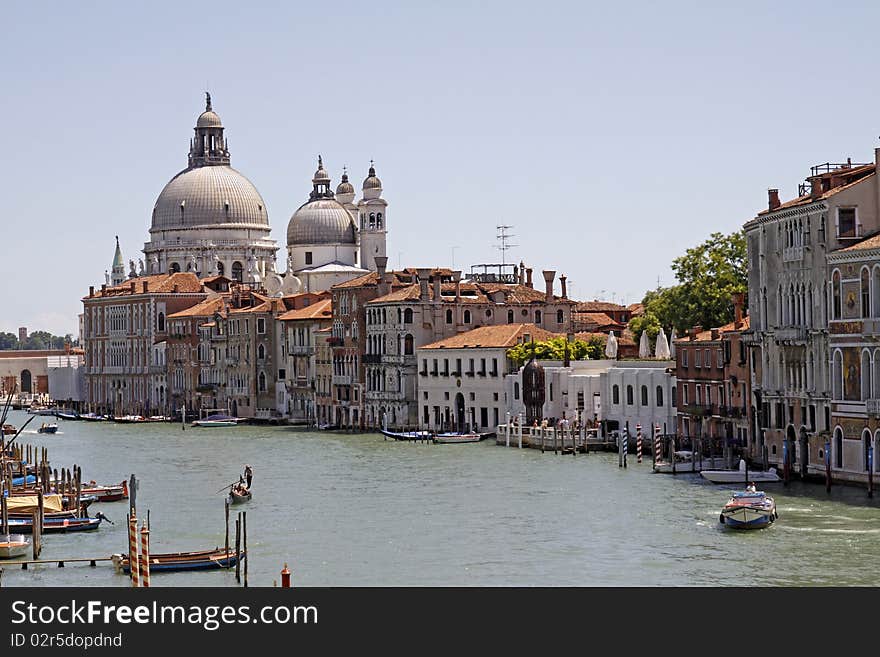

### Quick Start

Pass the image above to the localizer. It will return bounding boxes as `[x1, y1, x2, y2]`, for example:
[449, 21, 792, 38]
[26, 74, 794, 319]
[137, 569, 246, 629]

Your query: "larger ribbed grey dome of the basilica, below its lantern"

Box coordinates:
[150, 165, 269, 232]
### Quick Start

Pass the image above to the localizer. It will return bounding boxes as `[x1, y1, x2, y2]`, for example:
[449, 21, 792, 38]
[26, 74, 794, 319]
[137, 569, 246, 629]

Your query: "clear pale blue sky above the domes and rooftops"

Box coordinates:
[0, 0, 880, 335]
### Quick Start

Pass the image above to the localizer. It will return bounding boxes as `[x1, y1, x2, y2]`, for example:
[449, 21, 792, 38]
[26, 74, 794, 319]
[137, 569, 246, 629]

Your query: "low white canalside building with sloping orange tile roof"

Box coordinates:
[416, 324, 556, 431]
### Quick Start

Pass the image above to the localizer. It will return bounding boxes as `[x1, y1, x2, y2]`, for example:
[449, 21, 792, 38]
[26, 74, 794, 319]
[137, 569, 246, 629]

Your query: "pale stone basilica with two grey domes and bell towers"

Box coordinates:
[114, 94, 387, 294]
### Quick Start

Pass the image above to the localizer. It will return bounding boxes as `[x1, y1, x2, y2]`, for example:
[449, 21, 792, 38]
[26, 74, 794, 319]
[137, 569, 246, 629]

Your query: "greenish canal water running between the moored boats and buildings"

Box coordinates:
[2, 412, 880, 587]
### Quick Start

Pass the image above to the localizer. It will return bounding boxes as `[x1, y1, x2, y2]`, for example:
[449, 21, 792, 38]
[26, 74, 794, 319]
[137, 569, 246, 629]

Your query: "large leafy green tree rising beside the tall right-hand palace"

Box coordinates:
[630, 231, 748, 334]
